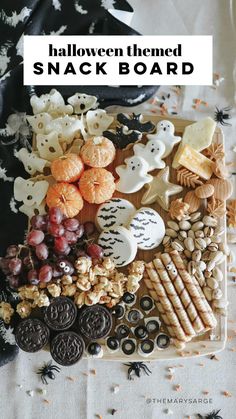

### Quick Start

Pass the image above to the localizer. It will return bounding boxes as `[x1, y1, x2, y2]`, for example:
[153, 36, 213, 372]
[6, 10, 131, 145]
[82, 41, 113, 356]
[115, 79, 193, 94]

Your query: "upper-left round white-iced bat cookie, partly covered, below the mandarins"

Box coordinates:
[95, 198, 136, 231]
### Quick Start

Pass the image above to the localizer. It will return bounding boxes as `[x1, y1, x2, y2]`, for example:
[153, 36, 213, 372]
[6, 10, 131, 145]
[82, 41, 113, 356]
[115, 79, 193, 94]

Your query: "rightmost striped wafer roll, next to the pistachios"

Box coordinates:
[170, 250, 215, 329]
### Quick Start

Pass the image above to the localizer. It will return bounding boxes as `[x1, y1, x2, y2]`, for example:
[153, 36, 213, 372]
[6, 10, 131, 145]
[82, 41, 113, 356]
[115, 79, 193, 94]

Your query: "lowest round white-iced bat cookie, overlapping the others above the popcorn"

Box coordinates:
[98, 226, 137, 266]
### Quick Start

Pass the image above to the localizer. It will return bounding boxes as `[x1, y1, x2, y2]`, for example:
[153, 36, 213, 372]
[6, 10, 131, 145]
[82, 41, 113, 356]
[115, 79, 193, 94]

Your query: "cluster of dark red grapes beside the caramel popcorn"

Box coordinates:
[0, 207, 103, 289]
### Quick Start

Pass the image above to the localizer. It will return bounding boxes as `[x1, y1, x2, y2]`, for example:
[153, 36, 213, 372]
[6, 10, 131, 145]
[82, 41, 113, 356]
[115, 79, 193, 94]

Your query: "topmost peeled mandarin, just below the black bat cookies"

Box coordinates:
[80, 137, 116, 167]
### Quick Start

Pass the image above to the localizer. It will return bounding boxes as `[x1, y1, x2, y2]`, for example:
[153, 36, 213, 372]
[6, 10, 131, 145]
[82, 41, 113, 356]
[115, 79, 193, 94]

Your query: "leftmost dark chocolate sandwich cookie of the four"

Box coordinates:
[15, 319, 49, 352]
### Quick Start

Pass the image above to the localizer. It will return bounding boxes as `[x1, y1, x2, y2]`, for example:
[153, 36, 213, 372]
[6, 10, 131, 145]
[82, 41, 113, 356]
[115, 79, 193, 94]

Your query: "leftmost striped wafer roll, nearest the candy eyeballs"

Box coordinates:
[146, 262, 191, 342]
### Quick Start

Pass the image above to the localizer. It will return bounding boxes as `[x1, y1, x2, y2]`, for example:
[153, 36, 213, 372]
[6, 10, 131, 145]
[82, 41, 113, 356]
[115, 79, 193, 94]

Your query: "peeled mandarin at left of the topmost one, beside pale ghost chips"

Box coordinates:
[51, 153, 84, 182]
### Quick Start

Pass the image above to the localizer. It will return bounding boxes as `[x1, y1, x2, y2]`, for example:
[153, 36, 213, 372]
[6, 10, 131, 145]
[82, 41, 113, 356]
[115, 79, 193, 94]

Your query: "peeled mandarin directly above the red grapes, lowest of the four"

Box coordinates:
[46, 182, 83, 218]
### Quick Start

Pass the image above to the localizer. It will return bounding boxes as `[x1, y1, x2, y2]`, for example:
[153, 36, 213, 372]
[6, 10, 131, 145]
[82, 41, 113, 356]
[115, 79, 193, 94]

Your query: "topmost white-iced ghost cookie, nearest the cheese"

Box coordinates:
[147, 120, 181, 158]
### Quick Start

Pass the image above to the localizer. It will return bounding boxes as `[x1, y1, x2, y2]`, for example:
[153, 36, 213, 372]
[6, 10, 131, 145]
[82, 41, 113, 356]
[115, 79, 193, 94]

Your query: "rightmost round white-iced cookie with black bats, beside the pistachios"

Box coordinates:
[128, 207, 165, 250]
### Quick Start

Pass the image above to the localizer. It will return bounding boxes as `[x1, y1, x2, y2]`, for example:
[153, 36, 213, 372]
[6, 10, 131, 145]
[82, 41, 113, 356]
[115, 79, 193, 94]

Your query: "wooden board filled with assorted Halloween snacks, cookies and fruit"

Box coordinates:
[0, 89, 229, 365]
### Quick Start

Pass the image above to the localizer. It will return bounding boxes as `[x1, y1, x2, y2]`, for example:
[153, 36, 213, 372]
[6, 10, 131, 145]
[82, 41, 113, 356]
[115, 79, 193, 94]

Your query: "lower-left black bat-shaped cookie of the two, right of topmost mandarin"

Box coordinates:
[103, 127, 142, 149]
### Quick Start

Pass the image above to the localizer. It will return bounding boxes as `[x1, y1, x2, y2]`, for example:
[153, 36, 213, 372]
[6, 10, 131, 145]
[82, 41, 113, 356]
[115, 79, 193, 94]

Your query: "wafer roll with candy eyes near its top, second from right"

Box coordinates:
[161, 253, 204, 333]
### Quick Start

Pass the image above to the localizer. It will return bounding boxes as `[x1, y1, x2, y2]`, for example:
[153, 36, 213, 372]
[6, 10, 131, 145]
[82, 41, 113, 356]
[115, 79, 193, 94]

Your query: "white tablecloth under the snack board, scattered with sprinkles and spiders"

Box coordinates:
[0, 0, 236, 419]
